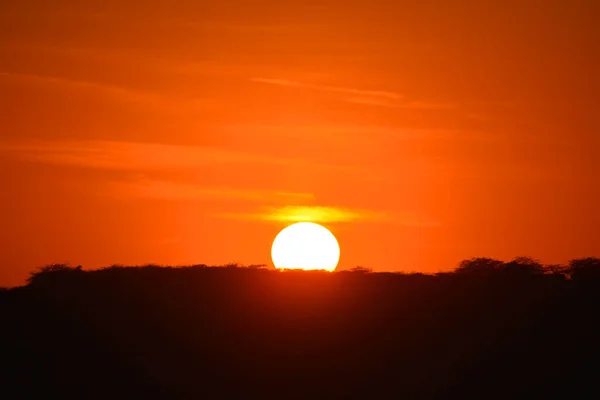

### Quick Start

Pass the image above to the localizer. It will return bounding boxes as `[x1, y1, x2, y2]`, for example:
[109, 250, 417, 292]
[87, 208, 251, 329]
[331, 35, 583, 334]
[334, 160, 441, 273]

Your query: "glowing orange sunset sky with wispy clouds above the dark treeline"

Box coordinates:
[0, 0, 600, 286]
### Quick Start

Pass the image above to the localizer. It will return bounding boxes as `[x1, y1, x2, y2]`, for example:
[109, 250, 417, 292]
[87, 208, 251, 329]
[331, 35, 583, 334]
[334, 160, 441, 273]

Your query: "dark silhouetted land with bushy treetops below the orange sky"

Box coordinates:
[0, 257, 600, 399]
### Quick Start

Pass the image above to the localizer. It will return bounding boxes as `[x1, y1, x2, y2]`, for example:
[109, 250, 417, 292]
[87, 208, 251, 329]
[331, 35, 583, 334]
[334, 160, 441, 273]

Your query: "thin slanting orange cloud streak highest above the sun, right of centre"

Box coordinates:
[252, 78, 455, 110]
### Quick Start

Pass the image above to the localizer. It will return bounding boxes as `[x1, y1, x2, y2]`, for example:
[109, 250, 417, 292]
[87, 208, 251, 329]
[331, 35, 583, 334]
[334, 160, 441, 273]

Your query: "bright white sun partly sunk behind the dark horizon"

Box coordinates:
[271, 222, 340, 271]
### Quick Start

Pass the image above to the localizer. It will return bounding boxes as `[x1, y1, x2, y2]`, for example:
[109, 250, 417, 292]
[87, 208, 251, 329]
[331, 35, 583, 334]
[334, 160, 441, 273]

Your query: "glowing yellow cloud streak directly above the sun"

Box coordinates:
[215, 205, 438, 226]
